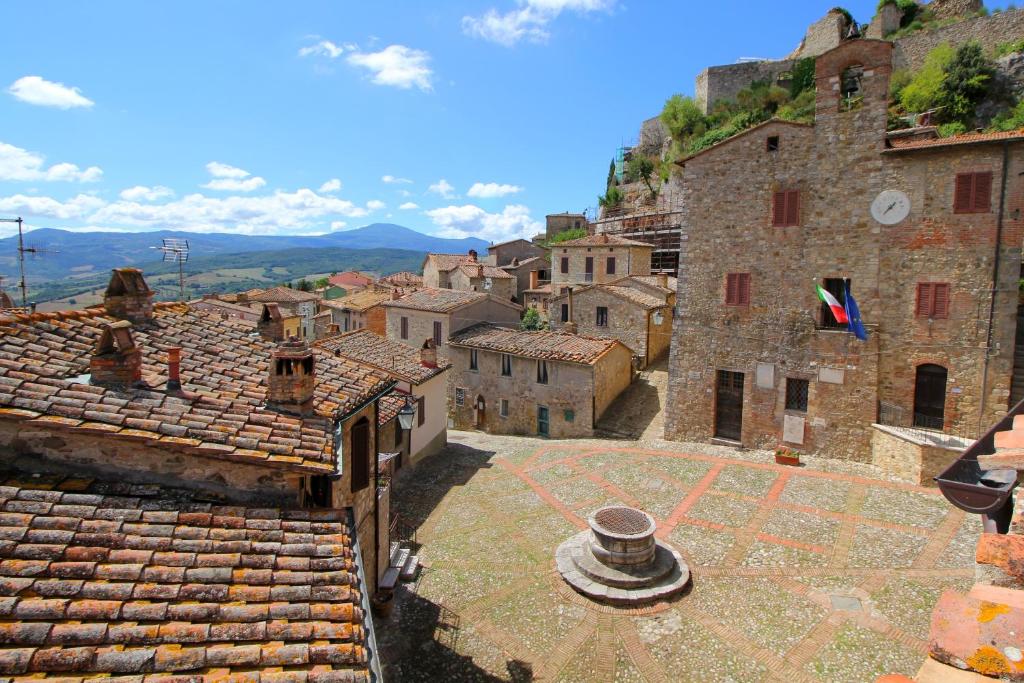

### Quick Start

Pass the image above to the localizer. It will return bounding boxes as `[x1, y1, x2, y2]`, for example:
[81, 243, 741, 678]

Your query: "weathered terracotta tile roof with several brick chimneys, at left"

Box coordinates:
[0, 304, 393, 472]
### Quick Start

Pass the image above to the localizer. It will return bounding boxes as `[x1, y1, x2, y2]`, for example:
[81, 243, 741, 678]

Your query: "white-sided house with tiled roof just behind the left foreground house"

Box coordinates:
[316, 330, 452, 469]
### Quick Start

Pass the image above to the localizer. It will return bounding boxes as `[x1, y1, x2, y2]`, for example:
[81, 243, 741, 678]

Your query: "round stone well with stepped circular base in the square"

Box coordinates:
[555, 505, 690, 605]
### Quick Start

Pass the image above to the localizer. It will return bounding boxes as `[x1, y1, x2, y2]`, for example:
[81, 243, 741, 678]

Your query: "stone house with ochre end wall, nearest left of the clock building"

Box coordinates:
[549, 275, 677, 368]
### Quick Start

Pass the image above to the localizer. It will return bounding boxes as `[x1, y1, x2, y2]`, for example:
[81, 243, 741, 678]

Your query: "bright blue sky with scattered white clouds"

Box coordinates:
[0, 0, 1006, 240]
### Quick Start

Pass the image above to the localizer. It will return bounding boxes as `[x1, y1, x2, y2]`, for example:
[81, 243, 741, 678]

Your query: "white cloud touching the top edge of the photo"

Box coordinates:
[462, 0, 615, 47]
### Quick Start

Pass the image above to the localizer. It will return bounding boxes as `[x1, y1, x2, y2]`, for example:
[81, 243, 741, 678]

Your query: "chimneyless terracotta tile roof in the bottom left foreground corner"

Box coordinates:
[0, 472, 370, 683]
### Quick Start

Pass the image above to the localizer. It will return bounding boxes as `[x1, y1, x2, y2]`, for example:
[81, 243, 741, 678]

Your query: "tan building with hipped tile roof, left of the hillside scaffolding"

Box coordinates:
[551, 232, 654, 295]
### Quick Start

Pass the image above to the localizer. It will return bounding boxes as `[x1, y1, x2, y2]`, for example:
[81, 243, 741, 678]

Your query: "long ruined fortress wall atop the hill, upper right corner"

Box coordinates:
[893, 8, 1024, 71]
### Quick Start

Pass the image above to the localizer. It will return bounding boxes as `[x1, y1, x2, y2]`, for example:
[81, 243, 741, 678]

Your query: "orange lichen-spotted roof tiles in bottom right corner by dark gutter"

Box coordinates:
[878, 416, 1024, 683]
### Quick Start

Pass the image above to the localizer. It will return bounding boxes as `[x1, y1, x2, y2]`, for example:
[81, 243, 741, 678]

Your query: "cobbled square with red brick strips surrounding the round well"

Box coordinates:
[378, 432, 980, 683]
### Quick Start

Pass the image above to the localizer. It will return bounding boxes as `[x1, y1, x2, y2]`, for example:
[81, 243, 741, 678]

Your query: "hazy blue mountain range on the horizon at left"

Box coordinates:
[0, 223, 487, 286]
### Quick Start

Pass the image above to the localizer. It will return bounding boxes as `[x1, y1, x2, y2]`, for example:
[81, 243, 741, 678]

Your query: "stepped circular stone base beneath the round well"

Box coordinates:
[555, 529, 690, 605]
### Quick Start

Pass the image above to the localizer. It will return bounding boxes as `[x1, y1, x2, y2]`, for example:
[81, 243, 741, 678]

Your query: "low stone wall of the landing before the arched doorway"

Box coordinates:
[871, 425, 971, 486]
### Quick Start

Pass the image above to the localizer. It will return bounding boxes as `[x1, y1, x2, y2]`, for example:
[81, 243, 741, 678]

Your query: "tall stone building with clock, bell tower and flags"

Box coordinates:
[666, 40, 1024, 460]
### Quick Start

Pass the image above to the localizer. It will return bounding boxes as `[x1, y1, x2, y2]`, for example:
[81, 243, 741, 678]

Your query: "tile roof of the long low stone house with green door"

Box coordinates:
[449, 323, 620, 365]
